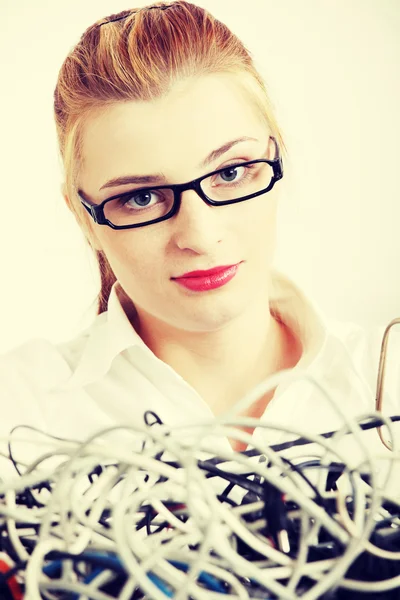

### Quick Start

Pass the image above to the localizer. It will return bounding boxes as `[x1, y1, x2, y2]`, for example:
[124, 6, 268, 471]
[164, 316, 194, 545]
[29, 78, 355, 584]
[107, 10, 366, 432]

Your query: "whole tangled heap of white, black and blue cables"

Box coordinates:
[0, 368, 400, 600]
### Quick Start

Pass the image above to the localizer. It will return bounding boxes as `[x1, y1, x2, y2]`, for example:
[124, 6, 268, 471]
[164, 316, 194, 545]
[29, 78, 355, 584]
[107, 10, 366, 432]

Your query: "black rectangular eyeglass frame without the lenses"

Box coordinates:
[78, 136, 283, 229]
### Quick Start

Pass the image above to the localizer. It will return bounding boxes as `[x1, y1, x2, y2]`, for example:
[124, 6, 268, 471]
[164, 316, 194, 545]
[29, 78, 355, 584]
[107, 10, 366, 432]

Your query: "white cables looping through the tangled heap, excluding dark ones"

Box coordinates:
[0, 386, 399, 600]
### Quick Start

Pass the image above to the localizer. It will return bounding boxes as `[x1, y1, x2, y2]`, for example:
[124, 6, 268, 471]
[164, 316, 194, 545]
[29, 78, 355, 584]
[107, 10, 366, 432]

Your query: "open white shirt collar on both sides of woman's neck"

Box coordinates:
[67, 270, 327, 387]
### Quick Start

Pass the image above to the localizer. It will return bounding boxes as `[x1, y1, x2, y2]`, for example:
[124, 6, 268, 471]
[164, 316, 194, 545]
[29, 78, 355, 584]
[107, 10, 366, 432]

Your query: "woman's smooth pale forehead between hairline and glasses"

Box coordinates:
[80, 74, 267, 193]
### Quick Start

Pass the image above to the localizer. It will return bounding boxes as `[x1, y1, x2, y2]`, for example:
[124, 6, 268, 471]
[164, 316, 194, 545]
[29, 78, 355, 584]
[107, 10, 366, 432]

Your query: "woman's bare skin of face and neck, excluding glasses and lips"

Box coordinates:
[78, 74, 301, 424]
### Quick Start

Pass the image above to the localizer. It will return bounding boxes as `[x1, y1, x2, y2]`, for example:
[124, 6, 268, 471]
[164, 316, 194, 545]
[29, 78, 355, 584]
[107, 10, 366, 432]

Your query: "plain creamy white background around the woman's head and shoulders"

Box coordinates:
[0, 0, 400, 352]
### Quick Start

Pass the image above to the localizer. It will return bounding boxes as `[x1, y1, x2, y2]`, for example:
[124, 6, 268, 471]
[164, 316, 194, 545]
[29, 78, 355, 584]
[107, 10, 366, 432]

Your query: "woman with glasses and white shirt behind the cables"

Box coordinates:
[2, 0, 398, 464]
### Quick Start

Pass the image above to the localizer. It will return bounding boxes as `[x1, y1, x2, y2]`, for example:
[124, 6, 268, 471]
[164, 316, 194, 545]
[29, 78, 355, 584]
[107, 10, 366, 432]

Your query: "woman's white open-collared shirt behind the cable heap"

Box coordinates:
[0, 272, 400, 488]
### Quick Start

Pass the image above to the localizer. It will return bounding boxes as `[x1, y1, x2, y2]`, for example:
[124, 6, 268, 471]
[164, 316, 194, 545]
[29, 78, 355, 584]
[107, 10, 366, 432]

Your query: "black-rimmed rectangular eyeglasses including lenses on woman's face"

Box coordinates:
[78, 137, 283, 229]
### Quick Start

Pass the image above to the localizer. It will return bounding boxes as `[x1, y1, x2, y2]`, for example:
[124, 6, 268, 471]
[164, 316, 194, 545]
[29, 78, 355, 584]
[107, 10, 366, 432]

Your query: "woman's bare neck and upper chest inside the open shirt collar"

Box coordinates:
[139, 296, 287, 414]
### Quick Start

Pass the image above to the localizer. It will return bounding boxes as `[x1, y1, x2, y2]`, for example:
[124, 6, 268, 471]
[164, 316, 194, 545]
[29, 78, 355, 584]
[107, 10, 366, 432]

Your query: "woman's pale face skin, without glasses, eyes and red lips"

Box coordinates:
[78, 75, 279, 332]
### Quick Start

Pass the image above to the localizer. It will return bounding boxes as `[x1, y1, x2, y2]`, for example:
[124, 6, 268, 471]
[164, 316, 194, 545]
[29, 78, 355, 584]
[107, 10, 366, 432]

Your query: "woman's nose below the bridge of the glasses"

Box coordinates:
[171, 190, 224, 254]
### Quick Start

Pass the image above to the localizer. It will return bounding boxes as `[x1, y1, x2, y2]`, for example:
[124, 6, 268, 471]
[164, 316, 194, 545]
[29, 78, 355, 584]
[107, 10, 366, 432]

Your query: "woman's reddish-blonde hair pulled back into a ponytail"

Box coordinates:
[54, 0, 284, 314]
